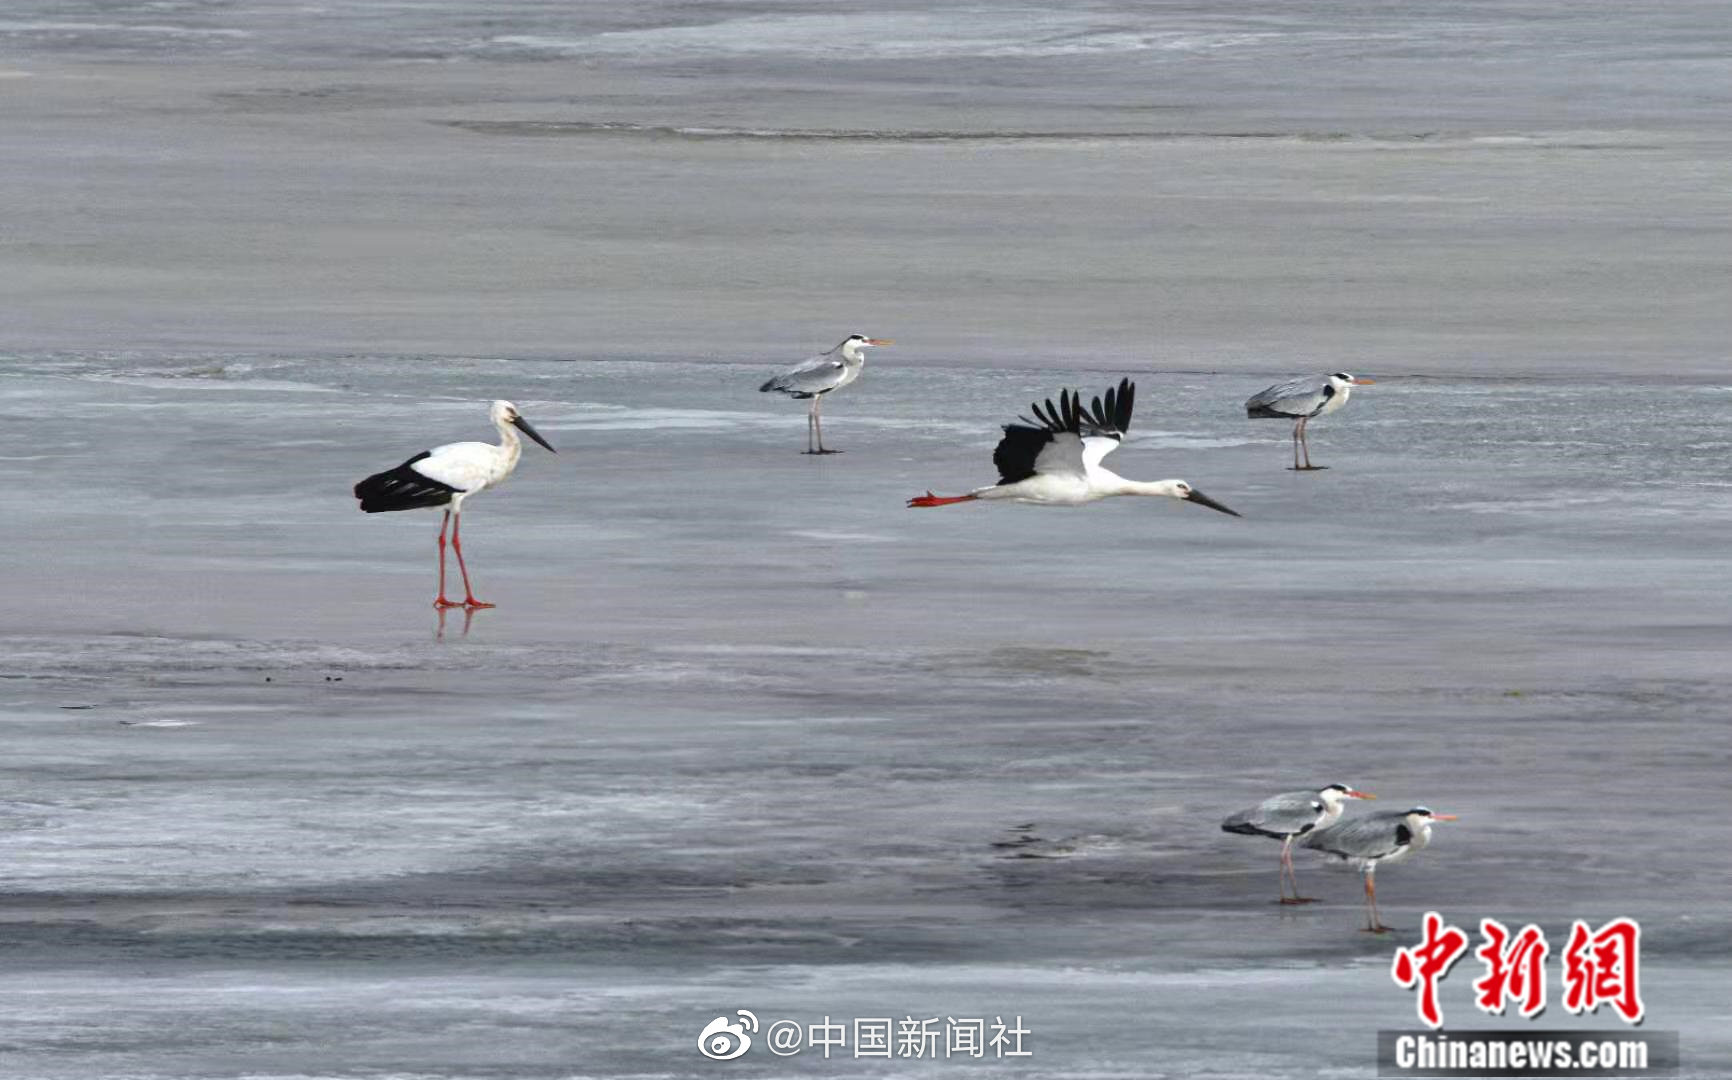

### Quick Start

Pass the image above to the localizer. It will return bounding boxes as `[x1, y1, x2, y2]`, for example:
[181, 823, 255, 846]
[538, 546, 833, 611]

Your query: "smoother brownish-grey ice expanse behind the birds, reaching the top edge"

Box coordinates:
[0, 0, 1732, 370]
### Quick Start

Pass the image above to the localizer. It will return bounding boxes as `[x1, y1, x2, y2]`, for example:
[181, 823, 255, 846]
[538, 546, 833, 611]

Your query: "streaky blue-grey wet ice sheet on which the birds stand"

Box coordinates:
[0, 358, 1732, 1078]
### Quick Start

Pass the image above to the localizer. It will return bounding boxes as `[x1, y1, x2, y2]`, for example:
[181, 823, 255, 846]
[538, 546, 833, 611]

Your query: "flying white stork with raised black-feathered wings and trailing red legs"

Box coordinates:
[908, 379, 1238, 518]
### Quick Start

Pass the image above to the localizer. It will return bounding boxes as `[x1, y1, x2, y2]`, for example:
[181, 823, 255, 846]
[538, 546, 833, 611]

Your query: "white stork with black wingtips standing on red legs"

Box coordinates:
[355, 402, 558, 611]
